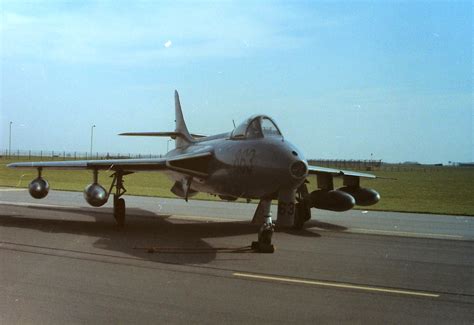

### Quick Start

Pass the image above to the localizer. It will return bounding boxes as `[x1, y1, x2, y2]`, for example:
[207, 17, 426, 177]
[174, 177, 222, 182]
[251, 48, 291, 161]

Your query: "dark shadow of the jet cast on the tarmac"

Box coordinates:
[0, 207, 343, 264]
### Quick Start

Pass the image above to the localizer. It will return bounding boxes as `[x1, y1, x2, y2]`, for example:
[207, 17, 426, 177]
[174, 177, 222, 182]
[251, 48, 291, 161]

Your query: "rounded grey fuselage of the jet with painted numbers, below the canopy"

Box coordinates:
[167, 133, 308, 199]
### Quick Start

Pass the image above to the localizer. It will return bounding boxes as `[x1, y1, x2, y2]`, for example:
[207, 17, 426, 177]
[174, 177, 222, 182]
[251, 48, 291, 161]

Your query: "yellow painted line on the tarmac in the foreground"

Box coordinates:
[233, 272, 439, 298]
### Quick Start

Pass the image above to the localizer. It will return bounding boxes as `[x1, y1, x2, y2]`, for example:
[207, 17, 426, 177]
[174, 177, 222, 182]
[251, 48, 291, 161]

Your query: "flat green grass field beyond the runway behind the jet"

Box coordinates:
[0, 159, 474, 216]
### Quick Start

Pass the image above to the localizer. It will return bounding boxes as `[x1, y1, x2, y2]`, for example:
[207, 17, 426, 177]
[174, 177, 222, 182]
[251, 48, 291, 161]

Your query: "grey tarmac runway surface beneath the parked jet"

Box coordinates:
[0, 189, 474, 324]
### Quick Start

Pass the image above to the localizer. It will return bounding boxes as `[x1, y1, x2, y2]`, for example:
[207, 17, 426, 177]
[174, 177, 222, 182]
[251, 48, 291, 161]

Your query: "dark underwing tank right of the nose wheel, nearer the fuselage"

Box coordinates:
[310, 190, 355, 212]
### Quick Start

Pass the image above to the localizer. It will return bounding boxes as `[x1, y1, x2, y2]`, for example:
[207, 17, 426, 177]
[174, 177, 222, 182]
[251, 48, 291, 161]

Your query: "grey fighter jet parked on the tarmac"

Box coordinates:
[8, 91, 380, 252]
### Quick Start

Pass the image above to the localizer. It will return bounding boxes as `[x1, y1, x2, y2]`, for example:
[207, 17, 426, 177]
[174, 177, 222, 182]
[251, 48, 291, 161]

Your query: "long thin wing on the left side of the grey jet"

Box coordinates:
[7, 151, 212, 177]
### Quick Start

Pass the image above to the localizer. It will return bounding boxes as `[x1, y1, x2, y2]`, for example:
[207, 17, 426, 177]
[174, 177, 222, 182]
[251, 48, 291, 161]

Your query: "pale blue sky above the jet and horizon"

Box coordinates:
[0, 0, 474, 163]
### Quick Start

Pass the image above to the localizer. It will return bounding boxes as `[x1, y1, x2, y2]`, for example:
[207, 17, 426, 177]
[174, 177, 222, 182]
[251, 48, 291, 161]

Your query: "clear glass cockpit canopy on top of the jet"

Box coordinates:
[231, 115, 282, 139]
